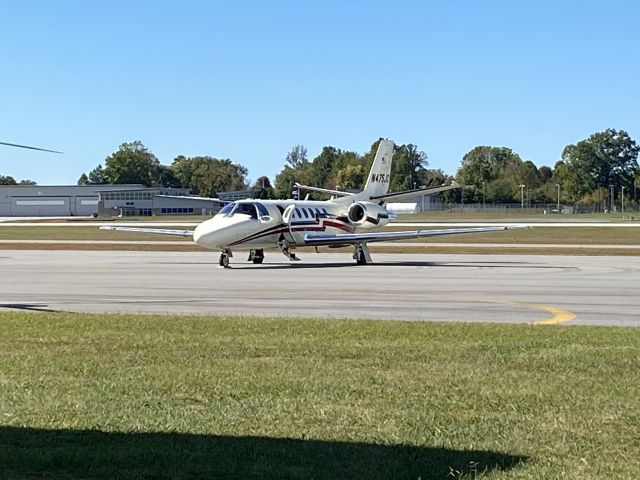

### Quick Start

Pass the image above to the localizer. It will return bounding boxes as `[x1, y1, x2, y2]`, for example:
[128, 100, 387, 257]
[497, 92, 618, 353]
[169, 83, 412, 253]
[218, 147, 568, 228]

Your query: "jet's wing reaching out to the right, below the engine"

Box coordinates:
[304, 225, 529, 246]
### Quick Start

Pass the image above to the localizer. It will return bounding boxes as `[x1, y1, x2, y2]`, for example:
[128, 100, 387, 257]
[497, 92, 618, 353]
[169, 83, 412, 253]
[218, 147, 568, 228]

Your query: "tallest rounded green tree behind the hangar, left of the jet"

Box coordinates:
[104, 140, 160, 187]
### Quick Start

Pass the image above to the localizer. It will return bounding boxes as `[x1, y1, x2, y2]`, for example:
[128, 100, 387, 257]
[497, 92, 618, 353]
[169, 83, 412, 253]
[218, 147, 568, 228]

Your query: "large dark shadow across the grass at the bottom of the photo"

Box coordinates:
[0, 427, 528, 480]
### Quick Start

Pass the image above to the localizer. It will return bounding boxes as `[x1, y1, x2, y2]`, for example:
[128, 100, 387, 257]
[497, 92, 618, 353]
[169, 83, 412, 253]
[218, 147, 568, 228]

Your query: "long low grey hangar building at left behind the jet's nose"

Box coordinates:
[0, 185, 221, 217]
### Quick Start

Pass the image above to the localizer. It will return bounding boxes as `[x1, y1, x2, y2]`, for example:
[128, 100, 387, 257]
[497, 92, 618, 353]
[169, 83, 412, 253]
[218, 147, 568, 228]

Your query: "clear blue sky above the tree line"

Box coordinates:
[0, 0, 640, 185]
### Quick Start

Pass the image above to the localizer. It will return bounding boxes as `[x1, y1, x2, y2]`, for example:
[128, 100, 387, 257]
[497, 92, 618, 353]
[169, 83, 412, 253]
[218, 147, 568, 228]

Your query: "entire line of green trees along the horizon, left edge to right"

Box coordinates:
[5, 129, 640, 205]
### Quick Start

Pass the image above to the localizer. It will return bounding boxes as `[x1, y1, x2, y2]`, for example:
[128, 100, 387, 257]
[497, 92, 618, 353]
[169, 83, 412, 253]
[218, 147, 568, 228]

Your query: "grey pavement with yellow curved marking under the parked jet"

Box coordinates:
[0, 250, 640, 326]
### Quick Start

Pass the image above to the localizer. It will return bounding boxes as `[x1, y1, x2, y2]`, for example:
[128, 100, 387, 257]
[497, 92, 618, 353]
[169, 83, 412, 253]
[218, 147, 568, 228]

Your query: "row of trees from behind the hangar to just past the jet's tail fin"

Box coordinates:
[78, 140, 447, 198]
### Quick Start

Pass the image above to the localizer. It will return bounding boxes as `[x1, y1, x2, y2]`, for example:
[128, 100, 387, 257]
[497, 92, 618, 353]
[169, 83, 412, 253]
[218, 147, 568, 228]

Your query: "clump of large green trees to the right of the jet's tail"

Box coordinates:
[455, 129, 640, 205]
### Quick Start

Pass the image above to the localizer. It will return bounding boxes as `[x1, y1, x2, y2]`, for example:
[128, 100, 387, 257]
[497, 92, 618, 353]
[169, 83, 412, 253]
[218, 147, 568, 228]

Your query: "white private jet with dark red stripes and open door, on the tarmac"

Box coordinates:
[100, 140, 521, 268]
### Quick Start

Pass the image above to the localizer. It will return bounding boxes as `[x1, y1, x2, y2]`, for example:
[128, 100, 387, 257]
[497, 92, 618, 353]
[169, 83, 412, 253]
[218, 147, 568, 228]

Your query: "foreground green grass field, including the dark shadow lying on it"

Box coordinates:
[0, 312, 640, 479]
